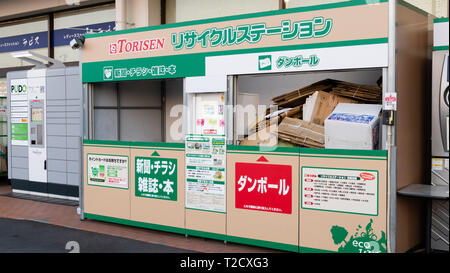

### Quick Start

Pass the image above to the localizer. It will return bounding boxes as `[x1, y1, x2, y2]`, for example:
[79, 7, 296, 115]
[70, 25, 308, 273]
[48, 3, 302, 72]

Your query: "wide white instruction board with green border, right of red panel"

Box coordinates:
[301, 167, 378, 216]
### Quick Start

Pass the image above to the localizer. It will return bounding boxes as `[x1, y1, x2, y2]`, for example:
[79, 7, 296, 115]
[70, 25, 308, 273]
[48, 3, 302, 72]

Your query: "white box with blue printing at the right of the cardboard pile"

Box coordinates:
[325, 103, 382, 150]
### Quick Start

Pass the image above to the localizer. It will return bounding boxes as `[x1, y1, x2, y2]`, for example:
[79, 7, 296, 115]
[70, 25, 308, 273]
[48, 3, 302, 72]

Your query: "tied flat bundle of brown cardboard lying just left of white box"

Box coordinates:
[278, 117, 325, 148]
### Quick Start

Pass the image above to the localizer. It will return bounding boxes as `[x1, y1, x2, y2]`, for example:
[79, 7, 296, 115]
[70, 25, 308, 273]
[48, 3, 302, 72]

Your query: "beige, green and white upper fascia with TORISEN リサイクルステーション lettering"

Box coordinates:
[81, 0, 388, 82]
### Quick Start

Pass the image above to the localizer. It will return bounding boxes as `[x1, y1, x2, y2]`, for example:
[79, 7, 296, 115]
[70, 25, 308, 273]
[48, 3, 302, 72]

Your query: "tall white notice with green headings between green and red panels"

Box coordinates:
[186, 135, 226, 212]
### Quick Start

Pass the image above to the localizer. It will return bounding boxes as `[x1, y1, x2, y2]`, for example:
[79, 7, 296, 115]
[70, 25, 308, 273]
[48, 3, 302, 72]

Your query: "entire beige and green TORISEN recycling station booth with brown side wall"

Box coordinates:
[80, 0, 429, 252]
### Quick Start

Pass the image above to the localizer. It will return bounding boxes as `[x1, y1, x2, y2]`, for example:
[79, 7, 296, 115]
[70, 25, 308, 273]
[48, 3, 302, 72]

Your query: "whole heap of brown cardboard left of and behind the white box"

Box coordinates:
[241, 79, 382, 148]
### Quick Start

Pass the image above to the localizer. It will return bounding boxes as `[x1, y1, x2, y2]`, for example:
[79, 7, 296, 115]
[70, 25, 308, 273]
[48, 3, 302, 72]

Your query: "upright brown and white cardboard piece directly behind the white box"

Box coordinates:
[303, 91, 356, 125]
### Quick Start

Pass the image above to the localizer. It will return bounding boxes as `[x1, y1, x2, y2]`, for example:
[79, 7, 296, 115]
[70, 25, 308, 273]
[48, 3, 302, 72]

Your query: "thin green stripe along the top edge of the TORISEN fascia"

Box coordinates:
[84, 0, 388, 39]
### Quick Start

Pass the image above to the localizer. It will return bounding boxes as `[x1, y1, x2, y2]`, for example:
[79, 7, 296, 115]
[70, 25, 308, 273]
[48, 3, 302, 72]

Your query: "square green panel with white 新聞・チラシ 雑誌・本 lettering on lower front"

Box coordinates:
[135, 157, 178, 201]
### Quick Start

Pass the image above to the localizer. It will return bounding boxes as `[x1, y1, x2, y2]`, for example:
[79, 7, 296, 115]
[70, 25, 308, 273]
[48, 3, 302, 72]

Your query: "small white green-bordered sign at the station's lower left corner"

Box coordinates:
[87, 154, 128, 189]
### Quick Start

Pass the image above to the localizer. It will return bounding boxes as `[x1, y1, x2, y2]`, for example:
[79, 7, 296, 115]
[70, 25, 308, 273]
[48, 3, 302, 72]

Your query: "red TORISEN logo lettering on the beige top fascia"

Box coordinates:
[109, 38, 164, 55]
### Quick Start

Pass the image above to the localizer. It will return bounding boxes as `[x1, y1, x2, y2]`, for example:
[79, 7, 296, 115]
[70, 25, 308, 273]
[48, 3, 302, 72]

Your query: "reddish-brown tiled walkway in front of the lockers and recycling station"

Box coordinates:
[0, 181, 280, 253]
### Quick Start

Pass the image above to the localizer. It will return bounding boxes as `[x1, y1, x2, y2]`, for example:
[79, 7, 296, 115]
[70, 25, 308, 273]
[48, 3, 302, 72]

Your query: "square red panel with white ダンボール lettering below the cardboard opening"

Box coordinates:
[235, 160, 292, 214]
